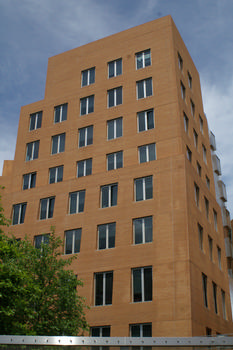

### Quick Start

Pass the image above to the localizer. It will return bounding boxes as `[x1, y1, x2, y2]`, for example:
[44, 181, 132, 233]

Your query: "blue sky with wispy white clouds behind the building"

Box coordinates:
[0, 0, 233, 217]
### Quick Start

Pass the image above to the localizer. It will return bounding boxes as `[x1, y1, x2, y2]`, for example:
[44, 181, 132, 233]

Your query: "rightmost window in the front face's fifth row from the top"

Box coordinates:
[134, 176, 153, 202]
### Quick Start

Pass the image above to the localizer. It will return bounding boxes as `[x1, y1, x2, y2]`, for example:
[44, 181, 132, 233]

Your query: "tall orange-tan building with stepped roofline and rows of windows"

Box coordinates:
[0, 16, 233, 336]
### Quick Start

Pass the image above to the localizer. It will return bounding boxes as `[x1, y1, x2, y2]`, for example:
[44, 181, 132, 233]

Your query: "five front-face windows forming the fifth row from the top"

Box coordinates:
[12, 176, 153, 225]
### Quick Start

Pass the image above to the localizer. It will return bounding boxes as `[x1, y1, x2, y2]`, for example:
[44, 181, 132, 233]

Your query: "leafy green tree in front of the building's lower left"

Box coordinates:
[0, 191, 88, 336]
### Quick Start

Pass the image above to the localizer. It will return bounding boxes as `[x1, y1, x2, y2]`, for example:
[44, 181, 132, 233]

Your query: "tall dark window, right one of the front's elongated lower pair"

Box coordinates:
[132, 266, 152, 303]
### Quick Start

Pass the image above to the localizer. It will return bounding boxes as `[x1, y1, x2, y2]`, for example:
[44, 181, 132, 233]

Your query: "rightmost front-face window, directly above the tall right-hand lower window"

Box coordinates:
[133, 216, 153, 244]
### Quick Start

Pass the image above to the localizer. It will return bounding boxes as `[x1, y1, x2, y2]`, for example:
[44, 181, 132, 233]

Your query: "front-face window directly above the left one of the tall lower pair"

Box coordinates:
[98, 222, 116, 250]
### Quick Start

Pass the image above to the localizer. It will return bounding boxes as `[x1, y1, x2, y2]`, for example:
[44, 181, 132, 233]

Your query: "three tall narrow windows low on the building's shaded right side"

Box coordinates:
[202, 273, 227, 320]
